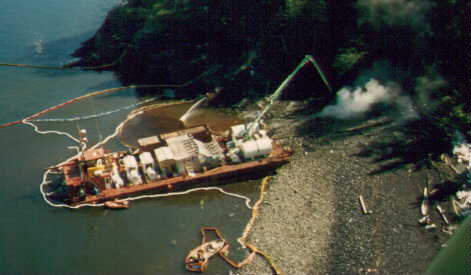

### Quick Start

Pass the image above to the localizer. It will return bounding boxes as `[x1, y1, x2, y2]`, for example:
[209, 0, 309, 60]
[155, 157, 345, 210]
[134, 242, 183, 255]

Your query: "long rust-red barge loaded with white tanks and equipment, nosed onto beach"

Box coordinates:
[48, 124, 292, 206]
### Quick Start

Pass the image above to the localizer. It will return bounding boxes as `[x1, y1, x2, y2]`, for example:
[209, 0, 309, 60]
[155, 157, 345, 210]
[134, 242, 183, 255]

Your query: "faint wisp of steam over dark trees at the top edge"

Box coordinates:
[356, 0, 434, 32]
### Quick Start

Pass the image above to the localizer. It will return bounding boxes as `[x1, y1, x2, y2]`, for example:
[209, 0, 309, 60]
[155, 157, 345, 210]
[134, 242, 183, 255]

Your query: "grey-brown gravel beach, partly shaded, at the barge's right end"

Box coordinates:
[240, 101, 449, 275]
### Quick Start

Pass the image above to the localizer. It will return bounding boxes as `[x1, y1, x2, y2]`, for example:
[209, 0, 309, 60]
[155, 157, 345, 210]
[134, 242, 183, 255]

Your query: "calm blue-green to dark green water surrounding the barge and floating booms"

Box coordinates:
[0, 0, 257, 274]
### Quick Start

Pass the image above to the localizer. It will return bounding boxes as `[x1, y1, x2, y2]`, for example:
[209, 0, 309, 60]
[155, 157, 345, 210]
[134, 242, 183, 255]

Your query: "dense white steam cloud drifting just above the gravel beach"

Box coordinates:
[320, 79, 417, 119]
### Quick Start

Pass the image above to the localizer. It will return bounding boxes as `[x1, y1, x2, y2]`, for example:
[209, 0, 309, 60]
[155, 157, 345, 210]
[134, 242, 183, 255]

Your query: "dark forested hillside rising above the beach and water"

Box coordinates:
[75, 0, 471, 135]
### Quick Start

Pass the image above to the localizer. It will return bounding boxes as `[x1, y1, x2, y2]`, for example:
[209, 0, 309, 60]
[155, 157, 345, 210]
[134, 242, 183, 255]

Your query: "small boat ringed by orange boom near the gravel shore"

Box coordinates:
[185, 239, 229, 272]
